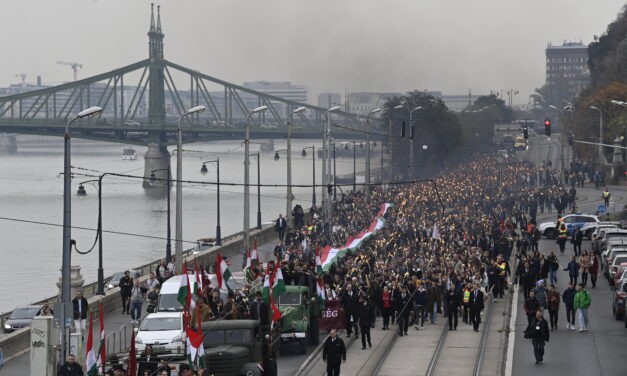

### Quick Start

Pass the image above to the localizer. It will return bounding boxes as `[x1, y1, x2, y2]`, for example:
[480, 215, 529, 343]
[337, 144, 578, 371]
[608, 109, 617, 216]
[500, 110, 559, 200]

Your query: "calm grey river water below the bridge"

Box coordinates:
[0, 136, 368, 312]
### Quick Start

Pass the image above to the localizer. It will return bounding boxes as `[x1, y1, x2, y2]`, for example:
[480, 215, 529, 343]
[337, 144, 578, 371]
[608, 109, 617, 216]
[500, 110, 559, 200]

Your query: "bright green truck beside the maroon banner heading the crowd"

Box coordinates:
[277, 286, 320, 354]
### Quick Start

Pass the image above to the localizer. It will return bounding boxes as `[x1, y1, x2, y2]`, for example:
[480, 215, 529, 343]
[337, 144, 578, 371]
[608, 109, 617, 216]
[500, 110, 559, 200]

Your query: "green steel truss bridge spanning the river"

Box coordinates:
[0, 5, 364, 150]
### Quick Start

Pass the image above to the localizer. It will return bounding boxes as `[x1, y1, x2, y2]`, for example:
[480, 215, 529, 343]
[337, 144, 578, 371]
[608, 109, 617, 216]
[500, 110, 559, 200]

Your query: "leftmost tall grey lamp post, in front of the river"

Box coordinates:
[60, 107, 102, 360]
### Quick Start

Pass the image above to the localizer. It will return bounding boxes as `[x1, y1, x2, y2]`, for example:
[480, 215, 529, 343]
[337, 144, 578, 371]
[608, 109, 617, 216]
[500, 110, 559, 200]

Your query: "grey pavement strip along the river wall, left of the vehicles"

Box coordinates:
[0, 238, 278, 376]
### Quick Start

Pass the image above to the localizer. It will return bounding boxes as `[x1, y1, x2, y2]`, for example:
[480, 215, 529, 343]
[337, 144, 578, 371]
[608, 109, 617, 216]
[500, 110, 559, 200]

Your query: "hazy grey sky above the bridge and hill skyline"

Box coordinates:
[0, 0, 625, 104]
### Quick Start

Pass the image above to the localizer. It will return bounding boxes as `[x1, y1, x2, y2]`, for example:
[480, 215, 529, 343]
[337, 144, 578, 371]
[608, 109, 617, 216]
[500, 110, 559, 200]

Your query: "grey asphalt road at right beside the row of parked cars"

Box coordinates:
[513, 189, 627, 376]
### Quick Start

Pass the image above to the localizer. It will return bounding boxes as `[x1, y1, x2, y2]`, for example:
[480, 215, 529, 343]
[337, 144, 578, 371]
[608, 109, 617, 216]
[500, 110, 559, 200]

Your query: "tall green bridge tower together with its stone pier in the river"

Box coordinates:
[143, 4, 171, 189]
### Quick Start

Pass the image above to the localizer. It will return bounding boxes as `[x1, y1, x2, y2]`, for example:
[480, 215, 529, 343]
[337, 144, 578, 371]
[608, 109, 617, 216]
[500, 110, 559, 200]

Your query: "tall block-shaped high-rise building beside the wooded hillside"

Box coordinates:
[546, 42, 590, 103]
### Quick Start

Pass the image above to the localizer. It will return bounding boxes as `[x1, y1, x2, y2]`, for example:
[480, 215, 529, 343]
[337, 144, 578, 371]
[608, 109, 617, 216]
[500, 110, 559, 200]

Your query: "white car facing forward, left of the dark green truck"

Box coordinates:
[135, 312, 187, 355]
